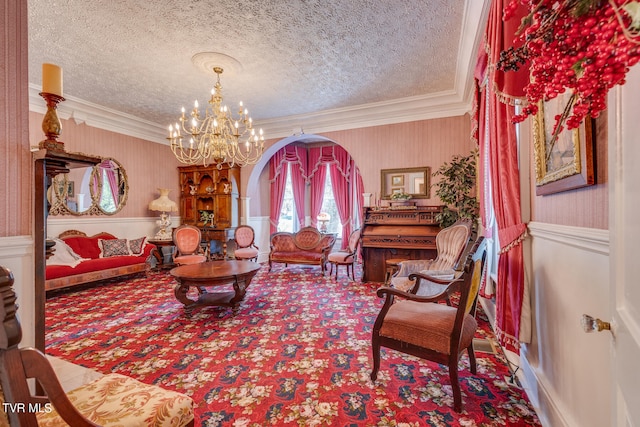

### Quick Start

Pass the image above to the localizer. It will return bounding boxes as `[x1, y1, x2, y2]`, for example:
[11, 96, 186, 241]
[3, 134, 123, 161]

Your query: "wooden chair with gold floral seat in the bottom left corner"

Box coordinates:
[0, 267, 194, 427]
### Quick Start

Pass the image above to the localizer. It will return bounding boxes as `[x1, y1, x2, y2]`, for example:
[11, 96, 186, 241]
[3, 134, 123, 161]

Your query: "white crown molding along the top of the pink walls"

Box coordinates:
[29, 0, 484, 145]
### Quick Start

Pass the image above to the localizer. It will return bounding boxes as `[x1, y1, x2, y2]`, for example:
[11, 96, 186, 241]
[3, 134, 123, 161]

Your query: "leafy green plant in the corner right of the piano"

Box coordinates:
[433, 150, 479, 228]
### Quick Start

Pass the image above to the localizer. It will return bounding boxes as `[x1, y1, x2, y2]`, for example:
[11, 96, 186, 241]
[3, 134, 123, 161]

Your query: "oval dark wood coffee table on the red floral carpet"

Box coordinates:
[169, 261, 260, 313]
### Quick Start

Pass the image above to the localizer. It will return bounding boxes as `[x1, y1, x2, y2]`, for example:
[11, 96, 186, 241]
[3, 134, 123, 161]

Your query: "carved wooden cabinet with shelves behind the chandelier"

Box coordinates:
[178, 164, 240, 252]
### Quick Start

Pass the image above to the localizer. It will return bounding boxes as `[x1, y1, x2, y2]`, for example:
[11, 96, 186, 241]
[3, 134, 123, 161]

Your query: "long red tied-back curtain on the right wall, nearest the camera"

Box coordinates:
[476, 0, 529, 352]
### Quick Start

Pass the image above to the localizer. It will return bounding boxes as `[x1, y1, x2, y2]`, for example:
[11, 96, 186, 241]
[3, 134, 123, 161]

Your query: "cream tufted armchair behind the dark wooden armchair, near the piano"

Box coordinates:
[390, 219, 472, 293]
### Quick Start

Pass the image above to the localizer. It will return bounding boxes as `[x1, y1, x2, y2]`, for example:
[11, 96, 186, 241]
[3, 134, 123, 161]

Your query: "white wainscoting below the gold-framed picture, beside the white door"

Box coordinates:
[520, 222, 612, 427]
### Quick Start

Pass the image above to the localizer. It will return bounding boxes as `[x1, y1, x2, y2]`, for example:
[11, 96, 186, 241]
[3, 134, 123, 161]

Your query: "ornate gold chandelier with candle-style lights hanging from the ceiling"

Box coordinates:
[167, 67, 264, 169]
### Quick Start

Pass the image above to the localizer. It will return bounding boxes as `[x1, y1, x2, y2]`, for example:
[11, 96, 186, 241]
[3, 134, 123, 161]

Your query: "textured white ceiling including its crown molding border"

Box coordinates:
[28, 0, 490, 140]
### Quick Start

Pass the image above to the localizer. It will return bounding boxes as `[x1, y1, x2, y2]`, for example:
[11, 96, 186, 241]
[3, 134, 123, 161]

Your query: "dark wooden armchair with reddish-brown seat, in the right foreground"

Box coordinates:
[371, 237, 485, 412]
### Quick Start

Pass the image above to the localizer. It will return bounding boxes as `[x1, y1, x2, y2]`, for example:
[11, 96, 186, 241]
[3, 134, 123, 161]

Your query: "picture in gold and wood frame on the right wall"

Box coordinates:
[533, 95, 596, 196]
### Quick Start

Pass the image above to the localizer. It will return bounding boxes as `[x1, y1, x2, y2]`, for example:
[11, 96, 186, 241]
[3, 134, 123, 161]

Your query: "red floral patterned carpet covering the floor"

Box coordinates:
[46, 266, 540, 427]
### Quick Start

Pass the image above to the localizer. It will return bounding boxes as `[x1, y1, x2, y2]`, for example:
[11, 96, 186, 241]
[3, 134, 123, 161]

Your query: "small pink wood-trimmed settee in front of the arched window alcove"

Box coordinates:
[269, 227, 336, 275]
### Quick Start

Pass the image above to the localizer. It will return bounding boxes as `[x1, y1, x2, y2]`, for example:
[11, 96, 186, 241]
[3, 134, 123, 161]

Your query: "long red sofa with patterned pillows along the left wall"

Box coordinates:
[45, 230, 157, 291]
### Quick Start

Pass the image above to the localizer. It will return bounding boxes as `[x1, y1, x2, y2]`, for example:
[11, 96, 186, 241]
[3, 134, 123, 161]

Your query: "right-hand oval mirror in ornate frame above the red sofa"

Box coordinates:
[91, 158, 129, 215]
